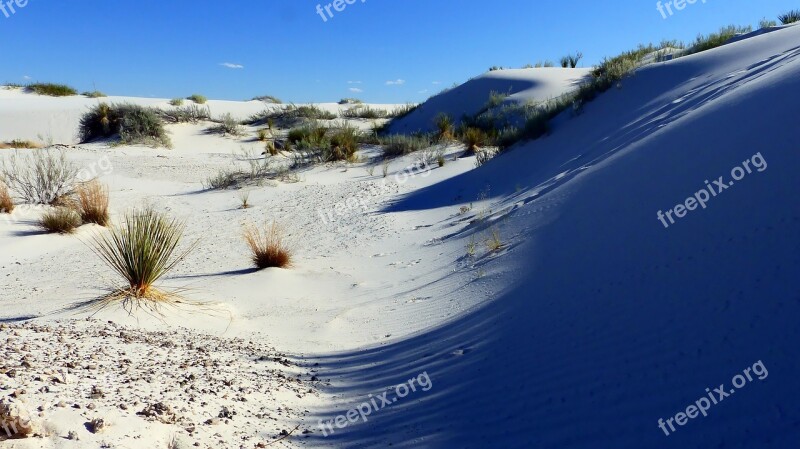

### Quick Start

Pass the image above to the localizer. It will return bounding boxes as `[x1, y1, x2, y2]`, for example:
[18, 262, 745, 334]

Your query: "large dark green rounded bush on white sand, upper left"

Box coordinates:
[78, 103, 172, 147]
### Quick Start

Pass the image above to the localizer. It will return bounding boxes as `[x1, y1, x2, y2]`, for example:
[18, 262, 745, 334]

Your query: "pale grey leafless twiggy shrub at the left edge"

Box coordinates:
[0, 150, 78, 204]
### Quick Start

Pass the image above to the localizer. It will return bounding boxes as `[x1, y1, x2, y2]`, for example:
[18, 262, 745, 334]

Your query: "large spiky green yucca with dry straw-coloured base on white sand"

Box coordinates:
[92, 207, 196, 300]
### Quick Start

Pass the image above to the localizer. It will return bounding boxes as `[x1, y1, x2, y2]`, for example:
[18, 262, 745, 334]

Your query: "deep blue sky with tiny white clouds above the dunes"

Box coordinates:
[0, 0, 799, 103]
